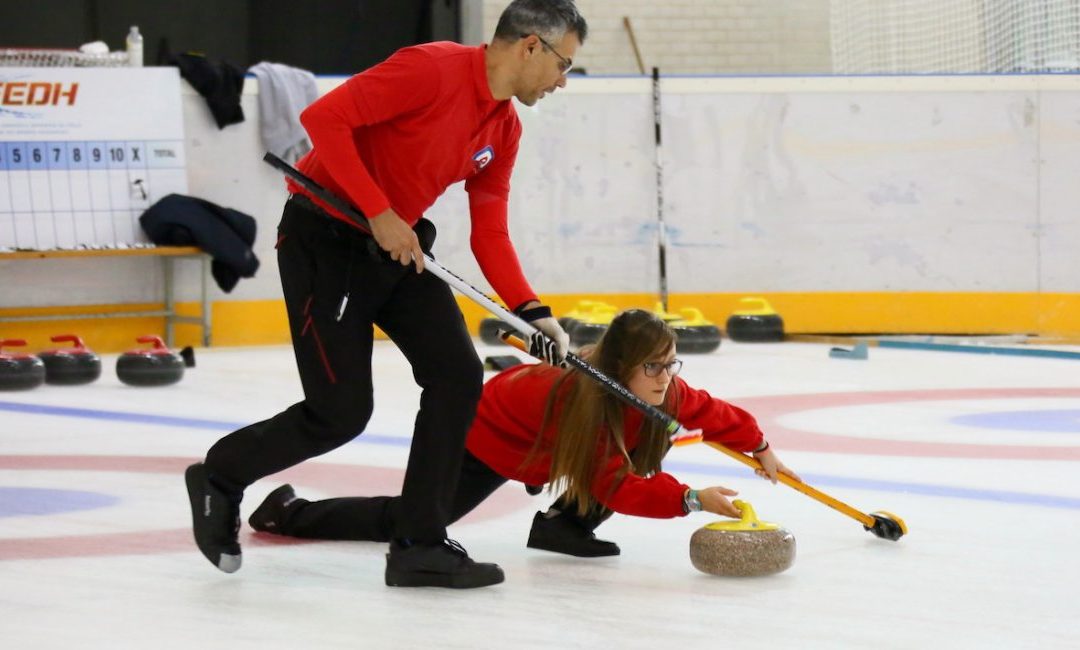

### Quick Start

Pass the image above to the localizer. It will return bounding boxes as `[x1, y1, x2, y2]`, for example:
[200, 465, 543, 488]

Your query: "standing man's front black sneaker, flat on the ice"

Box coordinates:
[387, 540, 505, 590]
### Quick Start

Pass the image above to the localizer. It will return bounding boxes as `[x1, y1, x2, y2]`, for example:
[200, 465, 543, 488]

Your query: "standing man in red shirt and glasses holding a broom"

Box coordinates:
[186, 0, 588, 587]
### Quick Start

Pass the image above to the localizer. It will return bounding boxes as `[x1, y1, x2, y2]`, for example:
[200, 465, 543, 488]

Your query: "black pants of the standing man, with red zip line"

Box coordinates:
[206, 197, 484, 542]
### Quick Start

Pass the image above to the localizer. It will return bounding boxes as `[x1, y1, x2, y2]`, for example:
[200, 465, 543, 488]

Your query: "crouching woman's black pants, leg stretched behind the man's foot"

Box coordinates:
[270, 451, 507, 542]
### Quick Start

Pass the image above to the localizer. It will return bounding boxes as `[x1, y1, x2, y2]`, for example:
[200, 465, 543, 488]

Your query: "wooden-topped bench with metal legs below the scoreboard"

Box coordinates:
[0, 246, 211, 348]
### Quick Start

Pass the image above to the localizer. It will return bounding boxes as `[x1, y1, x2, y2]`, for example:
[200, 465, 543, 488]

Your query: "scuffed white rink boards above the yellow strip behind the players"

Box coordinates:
[0, 76, 1080, 307]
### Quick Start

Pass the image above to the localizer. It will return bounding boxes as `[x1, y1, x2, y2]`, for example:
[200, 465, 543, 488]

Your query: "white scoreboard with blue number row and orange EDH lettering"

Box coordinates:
[0, 68, 187, 250]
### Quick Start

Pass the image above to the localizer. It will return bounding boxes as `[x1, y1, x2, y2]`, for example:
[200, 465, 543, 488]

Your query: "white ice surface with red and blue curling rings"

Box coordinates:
[0, 340, 1080, 650]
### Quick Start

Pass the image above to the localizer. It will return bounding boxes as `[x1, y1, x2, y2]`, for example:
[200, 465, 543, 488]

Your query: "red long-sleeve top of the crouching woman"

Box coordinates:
[465, 365, 764, 518]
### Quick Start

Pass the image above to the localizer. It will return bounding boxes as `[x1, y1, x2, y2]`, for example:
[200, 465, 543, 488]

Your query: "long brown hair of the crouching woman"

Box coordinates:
[525, 309, 677, 515]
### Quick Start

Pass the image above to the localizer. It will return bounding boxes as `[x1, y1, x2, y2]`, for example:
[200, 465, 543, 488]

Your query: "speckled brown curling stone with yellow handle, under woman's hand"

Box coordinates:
[690, 501, 795, 578]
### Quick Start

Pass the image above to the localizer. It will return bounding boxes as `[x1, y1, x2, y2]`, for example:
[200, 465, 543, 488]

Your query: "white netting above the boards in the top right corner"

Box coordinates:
[829, 0, 1080, 73]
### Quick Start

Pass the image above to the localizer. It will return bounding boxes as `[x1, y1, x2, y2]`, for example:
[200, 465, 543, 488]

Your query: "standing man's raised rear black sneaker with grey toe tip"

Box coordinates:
[184, 463, 241, 573]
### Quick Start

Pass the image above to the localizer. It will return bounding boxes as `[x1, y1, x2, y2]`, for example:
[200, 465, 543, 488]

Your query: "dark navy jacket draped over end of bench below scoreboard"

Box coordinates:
[138, 194, 259, 293]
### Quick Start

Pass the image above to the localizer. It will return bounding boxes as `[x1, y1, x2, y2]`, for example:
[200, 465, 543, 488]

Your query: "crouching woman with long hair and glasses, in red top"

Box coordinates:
[248, 310, 798, 556]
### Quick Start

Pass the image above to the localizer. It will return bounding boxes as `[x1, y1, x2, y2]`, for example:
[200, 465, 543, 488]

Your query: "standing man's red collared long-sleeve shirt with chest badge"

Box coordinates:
[289, 42, 536, 309]
